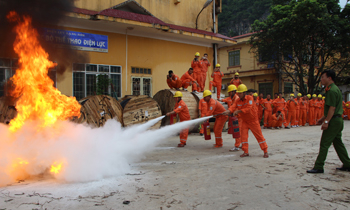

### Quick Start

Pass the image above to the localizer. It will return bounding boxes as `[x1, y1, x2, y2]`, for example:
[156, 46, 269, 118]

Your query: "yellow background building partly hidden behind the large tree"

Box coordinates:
[218, 33, 297, 97]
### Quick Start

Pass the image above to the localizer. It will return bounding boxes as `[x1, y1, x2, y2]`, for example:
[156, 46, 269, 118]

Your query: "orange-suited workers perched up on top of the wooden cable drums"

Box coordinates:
[167, 52, 242, 100]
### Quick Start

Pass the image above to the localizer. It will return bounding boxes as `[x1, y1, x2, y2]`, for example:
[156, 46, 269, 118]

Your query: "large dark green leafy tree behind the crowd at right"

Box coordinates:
[250, 0, 350, 94]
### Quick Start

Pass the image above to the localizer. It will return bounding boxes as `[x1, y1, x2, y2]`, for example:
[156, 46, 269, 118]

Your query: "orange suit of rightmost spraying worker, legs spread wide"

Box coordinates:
[229, 95, 267, 153]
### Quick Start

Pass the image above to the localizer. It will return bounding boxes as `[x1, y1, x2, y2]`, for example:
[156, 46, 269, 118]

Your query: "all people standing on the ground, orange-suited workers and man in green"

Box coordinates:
[166, 70, 350, 173]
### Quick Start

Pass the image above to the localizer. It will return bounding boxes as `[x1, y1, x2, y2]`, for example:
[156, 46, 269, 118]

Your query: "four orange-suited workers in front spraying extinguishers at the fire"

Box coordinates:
[166, 84, 269, 158]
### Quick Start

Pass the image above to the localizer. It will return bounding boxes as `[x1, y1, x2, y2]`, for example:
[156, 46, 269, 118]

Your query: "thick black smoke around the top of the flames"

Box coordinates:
[0, 0, 89, 78]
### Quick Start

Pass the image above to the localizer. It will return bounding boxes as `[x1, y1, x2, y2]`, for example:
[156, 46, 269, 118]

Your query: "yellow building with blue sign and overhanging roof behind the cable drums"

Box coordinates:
[0, 0, 236, 99]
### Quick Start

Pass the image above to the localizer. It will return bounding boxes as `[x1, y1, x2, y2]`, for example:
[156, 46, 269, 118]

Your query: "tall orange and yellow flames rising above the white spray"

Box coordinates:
[7, 12, 80, 132]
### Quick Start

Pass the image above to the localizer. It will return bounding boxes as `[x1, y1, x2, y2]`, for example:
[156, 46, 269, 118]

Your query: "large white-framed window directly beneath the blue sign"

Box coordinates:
[73, 63, 122, 100]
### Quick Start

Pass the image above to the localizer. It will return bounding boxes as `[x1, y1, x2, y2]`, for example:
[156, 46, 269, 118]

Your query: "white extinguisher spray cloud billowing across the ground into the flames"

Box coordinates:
[0, 117, 210, 185]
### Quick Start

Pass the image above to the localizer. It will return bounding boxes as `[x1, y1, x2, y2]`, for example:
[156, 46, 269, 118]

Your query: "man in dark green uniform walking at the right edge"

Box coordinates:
[307, 70, 350, 173]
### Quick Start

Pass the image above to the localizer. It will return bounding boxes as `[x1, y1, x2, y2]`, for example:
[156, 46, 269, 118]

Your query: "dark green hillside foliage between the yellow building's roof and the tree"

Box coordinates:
[219, 0, 273, 36]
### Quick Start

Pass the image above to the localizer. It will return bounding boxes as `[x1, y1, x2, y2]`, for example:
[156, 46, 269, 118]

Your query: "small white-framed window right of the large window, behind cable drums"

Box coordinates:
[131, 77, 152, 97]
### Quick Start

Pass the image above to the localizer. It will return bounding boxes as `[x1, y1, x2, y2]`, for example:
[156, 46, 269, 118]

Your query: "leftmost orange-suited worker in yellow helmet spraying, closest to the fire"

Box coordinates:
[166, 91, 191, 147]
